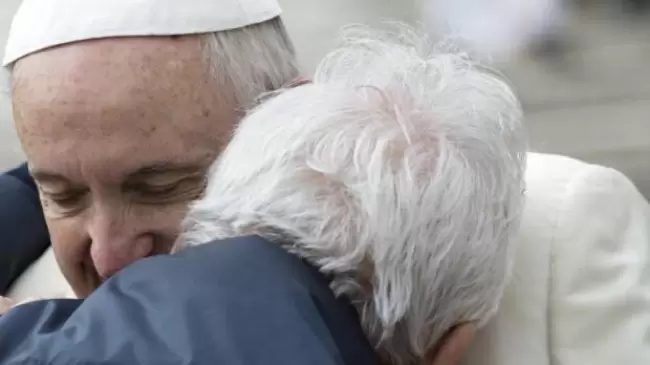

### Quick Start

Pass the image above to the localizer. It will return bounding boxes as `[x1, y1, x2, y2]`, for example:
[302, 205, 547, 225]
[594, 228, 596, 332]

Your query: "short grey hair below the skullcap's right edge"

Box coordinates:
[202, 17, 300, 107]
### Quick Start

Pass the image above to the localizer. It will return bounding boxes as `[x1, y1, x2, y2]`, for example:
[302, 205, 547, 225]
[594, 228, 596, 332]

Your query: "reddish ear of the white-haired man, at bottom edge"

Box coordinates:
[425, 323, 476, 365]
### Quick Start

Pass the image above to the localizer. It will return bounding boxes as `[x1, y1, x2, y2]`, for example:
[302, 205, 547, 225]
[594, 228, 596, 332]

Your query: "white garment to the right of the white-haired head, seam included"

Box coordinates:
[463, 153, 650, 365]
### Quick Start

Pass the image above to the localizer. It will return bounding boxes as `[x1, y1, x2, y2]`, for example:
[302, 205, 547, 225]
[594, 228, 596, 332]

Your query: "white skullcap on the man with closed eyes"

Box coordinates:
[2, 0, 281, 66]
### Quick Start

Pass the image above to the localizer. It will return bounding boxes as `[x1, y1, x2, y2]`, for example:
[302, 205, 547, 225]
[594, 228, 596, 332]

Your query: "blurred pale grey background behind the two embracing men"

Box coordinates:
[0, 0, 650, 197]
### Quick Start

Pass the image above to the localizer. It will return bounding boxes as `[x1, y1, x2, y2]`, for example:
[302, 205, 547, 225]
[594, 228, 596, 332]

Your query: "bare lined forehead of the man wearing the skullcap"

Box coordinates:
[12, 37, 236, 181]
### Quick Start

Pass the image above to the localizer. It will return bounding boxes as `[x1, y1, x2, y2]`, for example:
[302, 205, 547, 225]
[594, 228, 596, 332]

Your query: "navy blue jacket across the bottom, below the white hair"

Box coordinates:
[0, 237, 376, 365]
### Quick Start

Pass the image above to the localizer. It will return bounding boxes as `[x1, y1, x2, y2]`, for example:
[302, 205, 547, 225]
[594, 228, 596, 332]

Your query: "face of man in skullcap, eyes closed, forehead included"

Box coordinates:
[13, 37, 237, 296]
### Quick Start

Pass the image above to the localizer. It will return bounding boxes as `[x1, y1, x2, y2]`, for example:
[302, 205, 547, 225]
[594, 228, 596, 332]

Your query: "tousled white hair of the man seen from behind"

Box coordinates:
[179, 23, 526, 364]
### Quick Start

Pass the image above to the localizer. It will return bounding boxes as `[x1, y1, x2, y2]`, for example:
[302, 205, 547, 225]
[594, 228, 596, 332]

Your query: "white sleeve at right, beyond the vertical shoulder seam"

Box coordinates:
[549, 165, 650, 365]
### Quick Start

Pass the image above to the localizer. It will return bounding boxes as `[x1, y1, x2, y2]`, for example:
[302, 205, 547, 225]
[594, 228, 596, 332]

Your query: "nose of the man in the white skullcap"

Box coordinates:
[88, 208, 154, 279]
